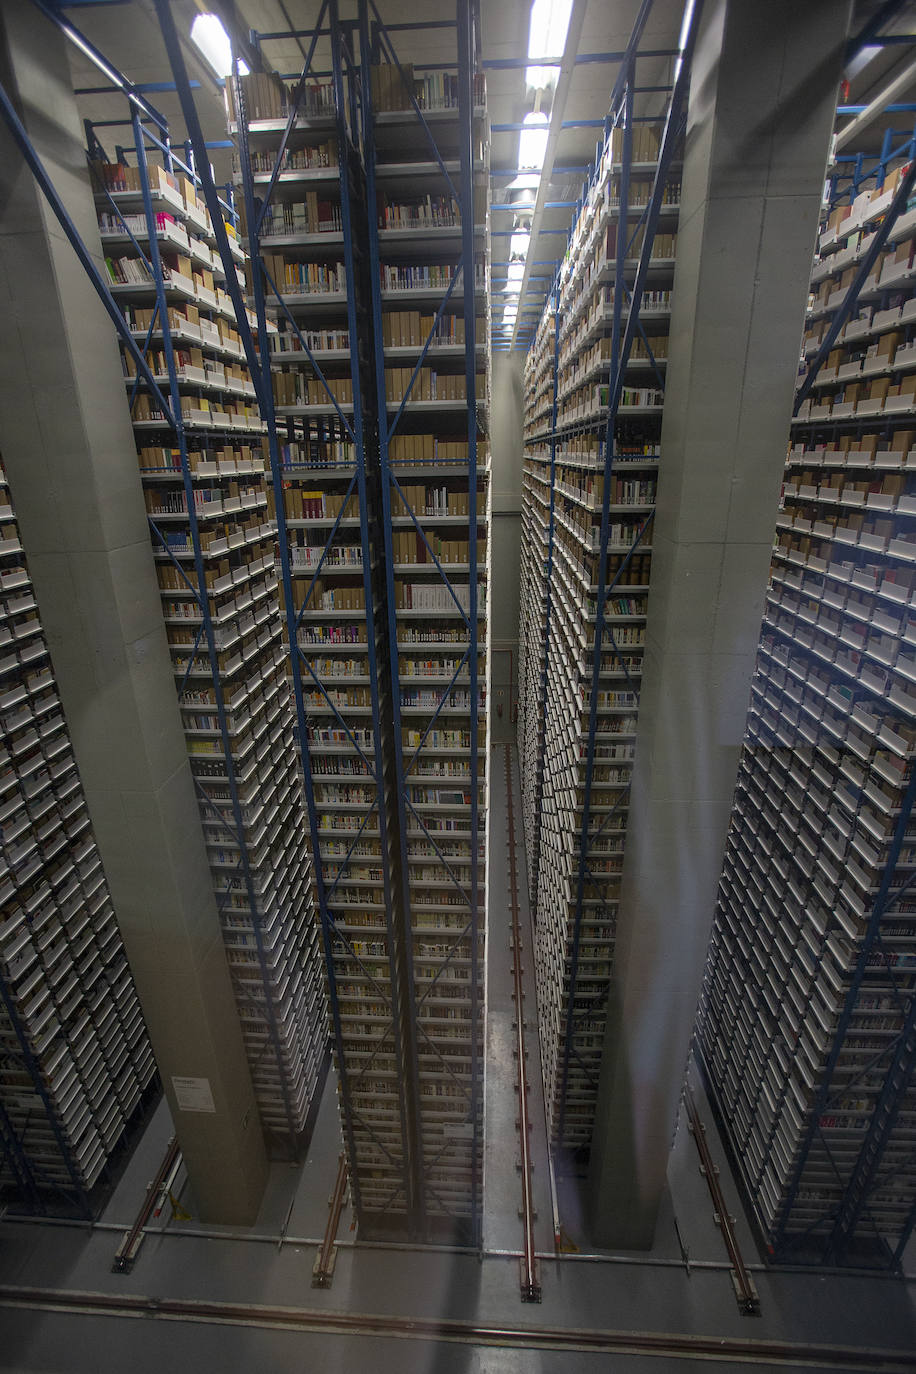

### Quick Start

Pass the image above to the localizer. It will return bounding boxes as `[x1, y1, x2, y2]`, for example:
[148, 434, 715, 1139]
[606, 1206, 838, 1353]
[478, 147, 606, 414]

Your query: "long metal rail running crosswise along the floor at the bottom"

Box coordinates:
[0, 1285, 916, 1374]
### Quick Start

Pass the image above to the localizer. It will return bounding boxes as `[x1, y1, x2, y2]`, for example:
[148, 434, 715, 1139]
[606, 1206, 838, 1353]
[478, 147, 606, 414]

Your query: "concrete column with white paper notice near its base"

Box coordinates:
[0, 4, 266, 1224]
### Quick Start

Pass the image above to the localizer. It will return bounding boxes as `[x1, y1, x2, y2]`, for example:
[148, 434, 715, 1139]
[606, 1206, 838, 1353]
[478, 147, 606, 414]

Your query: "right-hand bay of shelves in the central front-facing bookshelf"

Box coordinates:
[372, 56, 489, 1235]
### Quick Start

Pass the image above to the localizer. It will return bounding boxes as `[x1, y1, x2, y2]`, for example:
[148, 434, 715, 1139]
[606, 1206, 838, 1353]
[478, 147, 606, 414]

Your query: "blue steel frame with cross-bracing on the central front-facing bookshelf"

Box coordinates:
[184, 0, 482, 1245]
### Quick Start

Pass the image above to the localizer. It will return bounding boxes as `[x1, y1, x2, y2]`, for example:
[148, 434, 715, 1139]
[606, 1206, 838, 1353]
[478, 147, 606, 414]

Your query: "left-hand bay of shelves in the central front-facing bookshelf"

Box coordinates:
[233, 61, 417, 1224]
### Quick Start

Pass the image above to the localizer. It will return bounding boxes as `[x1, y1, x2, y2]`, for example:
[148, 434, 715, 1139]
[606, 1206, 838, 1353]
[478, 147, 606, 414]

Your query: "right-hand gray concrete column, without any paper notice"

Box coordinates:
[589, 0, 850, 1248]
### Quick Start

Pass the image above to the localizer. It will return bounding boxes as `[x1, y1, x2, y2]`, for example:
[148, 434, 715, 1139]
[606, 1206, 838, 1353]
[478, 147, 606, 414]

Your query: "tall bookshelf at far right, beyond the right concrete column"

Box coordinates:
[699, 120, 916, 1265]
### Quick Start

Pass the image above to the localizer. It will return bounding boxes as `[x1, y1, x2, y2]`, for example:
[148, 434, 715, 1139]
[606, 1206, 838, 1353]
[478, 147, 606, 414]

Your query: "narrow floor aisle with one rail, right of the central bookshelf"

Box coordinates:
[483, 745, 553, 1252]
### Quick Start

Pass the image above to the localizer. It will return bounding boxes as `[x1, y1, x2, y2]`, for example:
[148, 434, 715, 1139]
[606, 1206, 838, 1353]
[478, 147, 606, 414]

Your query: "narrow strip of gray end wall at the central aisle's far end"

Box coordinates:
[490, 350, 525, 743]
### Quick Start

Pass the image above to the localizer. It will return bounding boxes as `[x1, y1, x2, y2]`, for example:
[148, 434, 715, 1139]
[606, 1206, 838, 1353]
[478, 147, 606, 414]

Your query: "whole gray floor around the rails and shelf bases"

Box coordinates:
[0, 749, 916, 1374]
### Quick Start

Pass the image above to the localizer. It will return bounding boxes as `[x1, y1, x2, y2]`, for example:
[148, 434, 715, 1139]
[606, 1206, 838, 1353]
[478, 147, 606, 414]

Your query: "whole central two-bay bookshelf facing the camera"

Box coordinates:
[233, 4, 488, 1239]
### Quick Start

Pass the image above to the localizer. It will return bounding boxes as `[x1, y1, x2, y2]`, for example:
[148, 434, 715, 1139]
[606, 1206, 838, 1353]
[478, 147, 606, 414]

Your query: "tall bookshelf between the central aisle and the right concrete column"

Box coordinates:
[519, 107, 680, 1168]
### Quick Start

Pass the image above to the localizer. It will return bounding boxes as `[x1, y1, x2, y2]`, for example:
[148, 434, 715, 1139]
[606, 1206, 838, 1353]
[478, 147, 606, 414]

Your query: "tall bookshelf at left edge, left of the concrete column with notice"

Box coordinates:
[0, 445, 155, 1216]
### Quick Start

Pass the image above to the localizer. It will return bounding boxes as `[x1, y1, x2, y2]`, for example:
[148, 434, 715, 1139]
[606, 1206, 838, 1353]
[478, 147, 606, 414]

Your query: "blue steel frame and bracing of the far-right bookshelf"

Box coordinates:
[773, 123, 916, 1267]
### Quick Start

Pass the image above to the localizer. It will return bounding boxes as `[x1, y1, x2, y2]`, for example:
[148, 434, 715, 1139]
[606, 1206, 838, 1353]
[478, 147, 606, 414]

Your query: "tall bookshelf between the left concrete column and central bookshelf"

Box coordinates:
[92, 147, 325, 1138]
